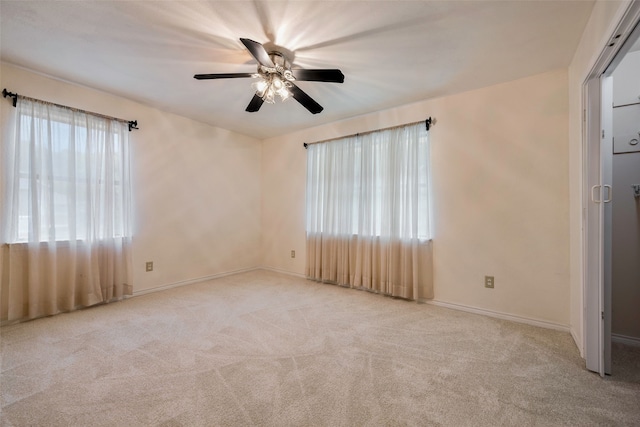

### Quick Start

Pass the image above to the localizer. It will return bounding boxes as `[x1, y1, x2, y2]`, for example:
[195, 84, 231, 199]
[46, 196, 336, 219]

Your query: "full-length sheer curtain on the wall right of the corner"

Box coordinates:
[306, 123, 433, 300]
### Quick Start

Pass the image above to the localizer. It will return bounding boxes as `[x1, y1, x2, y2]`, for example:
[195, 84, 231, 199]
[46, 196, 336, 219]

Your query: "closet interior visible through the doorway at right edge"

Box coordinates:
[602, 30, 640, 375]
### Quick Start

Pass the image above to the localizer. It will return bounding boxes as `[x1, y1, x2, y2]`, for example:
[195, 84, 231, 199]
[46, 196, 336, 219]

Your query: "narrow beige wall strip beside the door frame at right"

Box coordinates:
[569, 1, 629, 354]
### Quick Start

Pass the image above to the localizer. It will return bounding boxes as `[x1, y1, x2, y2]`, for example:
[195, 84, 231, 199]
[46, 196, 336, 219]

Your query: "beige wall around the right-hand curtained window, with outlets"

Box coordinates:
[262, 70, 569, 326]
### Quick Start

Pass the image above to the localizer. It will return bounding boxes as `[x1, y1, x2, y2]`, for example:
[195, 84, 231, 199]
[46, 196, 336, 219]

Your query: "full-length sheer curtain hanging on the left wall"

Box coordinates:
[0, 98, 132, 321]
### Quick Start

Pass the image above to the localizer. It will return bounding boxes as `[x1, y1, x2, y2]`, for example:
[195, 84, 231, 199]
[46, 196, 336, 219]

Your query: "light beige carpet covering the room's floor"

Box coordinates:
[0, 271, 640, 426]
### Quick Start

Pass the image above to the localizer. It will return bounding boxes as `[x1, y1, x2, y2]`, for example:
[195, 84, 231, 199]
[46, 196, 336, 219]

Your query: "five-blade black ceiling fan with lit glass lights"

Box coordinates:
[193, 38, 344, 114]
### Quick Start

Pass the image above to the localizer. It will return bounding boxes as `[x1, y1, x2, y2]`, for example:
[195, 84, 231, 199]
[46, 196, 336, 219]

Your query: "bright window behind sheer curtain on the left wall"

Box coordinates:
[9, 101, 131, 243]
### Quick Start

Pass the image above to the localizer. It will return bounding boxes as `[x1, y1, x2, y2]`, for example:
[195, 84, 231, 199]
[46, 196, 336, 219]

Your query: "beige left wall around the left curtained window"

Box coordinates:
[0, 64, 262, 292]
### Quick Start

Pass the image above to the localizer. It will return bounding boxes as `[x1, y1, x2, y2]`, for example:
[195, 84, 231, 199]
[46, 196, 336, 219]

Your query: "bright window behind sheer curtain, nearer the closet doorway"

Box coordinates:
[307, 123, 431, 240]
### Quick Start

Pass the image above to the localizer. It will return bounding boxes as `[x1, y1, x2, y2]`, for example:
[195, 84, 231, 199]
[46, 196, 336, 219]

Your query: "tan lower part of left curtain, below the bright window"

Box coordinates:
[2, 239, 132, 321]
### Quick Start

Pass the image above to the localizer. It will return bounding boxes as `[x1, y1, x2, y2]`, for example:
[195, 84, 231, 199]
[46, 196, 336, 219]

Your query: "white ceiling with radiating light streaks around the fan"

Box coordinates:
[0, 0, 593, 139]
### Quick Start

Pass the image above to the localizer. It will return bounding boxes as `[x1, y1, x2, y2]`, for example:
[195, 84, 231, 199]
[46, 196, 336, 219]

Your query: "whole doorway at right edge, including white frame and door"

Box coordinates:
[583, 2, 640, 378]
